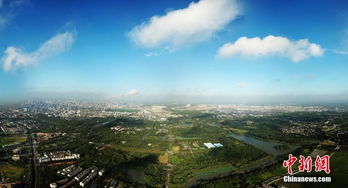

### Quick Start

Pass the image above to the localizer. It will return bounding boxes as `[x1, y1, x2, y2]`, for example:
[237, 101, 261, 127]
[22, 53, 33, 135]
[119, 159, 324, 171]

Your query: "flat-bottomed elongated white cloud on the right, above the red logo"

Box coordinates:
[218, 35, 324, 62]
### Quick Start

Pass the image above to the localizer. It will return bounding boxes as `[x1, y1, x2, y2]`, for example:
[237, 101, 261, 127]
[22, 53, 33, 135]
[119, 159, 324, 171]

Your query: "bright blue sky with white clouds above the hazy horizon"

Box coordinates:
[0, 0, 348, 101]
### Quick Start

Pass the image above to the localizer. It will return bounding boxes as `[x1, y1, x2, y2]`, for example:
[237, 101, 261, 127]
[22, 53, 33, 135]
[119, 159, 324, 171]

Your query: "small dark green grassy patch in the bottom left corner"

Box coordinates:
[0, 163, 24, 182]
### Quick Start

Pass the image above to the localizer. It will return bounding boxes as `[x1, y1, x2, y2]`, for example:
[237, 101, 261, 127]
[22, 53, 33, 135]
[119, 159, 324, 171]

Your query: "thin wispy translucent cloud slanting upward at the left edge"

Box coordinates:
[2, 31, 75, 72]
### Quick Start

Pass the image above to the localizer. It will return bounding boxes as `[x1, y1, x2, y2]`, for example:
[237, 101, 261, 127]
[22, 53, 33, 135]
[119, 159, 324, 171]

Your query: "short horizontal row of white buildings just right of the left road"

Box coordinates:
[38, 150, 80, 163]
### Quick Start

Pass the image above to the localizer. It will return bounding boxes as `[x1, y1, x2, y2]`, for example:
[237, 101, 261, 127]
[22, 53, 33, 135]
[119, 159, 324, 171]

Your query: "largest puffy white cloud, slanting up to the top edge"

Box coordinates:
[128, 0, 239, 48]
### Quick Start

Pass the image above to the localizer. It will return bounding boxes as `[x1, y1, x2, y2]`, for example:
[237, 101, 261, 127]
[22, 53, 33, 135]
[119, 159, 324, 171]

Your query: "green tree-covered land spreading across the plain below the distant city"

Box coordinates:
[0, 111, 348, 187]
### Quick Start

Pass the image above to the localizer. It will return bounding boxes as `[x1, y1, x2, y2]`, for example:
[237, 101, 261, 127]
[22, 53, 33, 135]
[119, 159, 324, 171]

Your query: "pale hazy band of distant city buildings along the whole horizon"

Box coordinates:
[4, 100, 346, 121]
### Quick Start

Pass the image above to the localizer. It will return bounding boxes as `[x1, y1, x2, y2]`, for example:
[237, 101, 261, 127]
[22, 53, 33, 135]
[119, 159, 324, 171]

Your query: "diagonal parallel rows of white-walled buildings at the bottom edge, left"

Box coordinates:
[50, 164, 105, 188]
